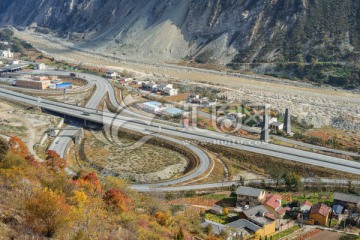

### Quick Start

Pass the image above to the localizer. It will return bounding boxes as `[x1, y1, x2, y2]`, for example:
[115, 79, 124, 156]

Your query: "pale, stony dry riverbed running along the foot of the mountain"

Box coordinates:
[16, 32, 360, 130]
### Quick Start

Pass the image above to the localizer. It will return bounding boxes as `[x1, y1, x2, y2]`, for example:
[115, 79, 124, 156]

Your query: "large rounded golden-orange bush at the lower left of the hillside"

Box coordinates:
[25, 188, 70, 237]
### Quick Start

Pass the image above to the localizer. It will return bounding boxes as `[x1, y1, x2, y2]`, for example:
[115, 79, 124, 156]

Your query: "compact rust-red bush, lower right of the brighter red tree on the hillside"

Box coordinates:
[103, 188, 132, 212]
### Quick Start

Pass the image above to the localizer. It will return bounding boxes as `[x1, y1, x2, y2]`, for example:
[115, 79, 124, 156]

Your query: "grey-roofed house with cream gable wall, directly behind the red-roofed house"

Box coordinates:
[236, 186, 265, 207]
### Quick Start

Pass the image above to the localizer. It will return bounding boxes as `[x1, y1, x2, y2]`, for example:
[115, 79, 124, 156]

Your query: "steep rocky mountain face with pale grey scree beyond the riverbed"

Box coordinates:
[0, 0, 360, 63]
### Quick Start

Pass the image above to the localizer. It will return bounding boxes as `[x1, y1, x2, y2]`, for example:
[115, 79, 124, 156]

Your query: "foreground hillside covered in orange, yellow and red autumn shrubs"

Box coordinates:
[0, 137, 212, 240]
